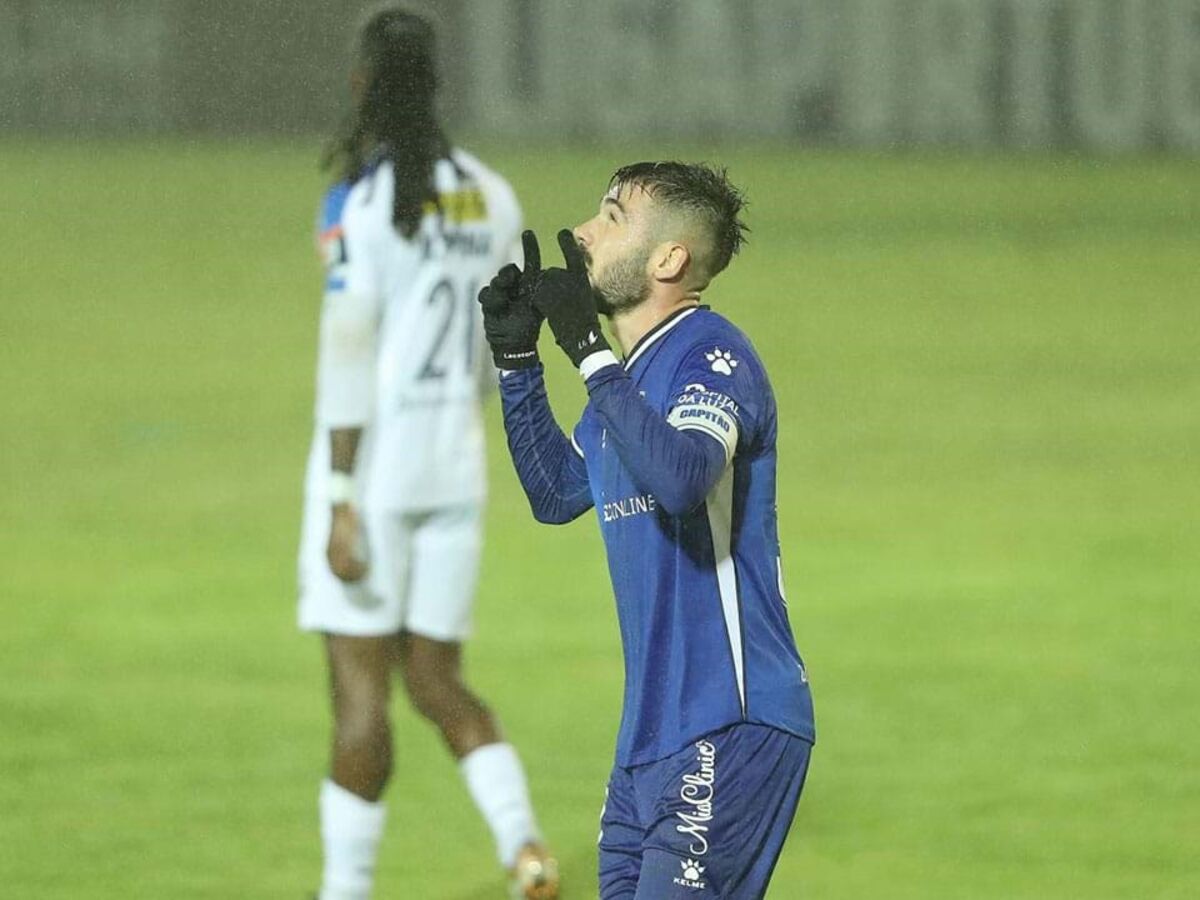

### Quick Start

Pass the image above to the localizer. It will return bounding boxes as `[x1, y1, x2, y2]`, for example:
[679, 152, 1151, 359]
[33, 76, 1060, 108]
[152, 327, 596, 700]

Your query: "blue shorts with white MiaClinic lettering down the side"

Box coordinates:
[600, 722, 812, 900]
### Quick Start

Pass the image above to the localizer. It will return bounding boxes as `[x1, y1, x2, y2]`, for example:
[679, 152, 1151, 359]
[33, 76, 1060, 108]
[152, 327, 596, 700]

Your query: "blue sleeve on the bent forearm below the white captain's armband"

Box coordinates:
[587, 366, 728, 516]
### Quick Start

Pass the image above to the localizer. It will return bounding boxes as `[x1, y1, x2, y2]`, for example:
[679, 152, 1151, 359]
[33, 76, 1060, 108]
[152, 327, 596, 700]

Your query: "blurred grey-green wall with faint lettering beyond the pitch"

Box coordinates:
[0, 0, 1200, 154]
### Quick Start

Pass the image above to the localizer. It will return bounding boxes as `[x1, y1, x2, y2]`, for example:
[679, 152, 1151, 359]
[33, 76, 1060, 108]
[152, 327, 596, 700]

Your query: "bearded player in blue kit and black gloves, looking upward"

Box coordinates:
[480, 162, 815, 900]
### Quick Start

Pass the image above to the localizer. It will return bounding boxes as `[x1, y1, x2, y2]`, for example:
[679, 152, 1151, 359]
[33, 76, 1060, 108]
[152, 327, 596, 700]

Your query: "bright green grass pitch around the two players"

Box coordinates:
[0, 140, 1200, 900]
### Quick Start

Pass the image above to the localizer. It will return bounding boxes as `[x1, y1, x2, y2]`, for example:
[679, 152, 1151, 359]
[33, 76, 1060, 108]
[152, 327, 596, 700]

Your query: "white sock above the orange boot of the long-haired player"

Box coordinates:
[458, 744, 541, 869]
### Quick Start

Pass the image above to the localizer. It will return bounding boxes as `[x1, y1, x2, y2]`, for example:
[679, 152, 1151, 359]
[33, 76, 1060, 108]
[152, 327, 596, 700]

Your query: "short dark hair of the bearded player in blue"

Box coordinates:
[608, 161, 750, 282]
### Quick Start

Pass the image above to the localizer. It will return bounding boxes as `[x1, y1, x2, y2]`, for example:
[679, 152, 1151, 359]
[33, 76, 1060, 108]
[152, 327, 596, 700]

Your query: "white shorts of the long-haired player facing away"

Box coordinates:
[299, 501, 482, 641]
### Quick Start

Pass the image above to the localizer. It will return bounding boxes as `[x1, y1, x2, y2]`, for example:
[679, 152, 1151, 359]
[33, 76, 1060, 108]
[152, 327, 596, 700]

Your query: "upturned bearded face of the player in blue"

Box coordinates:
[575, 187, 653, 316]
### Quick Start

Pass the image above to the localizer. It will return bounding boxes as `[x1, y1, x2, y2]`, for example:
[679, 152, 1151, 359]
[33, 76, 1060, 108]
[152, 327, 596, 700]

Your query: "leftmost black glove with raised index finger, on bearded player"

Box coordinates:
[479, 232, 542, 370]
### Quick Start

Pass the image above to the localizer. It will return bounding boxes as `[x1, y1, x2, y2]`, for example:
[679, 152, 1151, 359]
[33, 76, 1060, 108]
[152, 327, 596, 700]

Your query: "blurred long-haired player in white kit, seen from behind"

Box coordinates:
[299, 8, 558, 900]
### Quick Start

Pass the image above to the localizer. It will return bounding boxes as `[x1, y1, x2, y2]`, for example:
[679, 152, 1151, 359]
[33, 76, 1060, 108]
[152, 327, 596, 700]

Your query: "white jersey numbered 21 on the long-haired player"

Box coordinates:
[308, 149, 521, 509]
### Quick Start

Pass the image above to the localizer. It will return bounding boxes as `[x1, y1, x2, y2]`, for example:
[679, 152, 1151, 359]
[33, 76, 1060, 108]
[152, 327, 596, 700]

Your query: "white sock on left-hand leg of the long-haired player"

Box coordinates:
[320, 779, 388, 900]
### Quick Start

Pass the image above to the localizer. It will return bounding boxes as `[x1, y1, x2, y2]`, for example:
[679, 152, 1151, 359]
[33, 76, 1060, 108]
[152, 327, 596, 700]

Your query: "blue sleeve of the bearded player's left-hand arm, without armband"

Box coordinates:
[500, 365, 592, 524]
